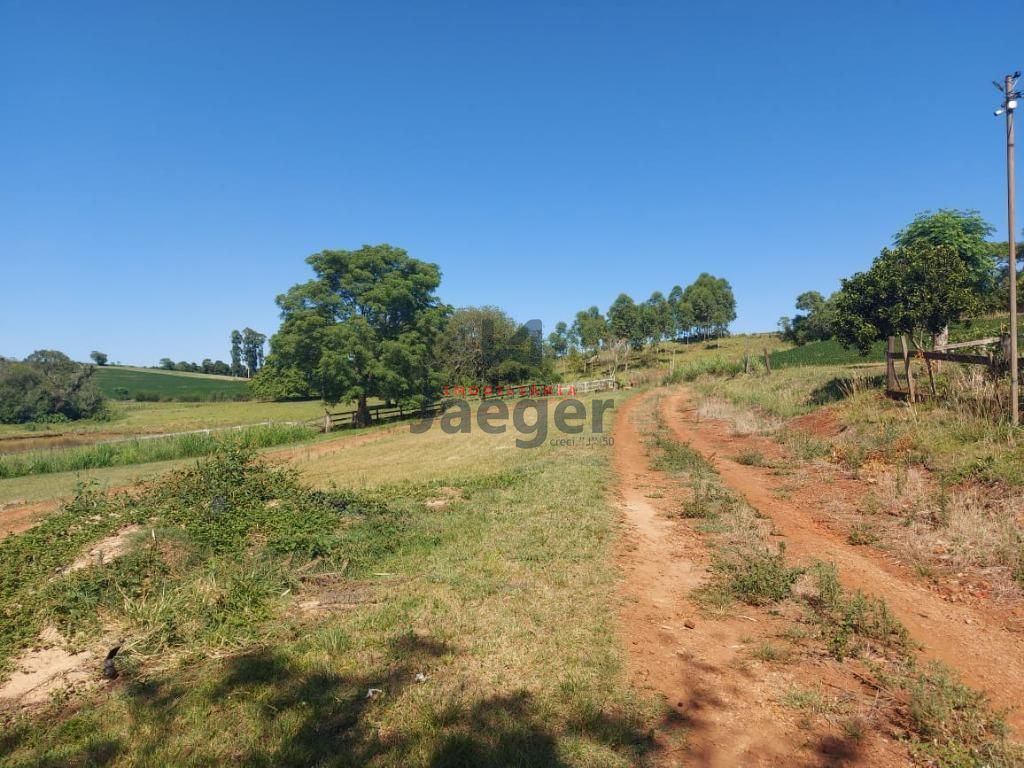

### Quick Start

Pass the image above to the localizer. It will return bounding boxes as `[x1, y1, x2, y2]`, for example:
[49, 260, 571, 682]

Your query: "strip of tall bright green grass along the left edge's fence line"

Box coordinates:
[0, 424, 314, 479]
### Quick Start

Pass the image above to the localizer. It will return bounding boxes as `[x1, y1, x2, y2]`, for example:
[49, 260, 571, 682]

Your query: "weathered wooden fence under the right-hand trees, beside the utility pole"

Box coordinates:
[886, 334, 1024, 401]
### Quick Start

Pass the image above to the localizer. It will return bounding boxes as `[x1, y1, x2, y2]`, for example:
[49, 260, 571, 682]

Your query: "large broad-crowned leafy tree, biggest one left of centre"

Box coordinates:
[257, 245, 449, 425]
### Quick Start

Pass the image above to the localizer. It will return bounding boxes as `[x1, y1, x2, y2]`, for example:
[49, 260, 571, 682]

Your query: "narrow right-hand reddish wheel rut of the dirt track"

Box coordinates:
[662, 391, 1024, 733]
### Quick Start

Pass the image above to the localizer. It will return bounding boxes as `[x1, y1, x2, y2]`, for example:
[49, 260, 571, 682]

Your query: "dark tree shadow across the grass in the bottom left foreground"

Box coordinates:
[0, 633, 668, 768]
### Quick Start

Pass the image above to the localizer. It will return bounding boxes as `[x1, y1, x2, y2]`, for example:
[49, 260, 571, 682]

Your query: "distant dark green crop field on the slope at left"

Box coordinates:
[93, 366, 249, 402]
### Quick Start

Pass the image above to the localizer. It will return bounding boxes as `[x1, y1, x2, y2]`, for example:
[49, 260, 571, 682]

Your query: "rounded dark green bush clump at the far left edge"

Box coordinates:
[0, 349, 103, 424]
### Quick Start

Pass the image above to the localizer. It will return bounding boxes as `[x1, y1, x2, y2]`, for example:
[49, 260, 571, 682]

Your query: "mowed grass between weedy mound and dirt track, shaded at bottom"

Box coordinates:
[0, 393, 667, 766]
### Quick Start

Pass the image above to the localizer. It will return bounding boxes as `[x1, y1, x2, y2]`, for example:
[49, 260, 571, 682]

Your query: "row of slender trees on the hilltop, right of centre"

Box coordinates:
[548, 272, 736, 356]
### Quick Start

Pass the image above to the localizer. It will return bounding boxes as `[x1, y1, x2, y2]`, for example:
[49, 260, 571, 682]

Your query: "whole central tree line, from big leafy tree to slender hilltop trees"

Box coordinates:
[250, 245, 735, 424]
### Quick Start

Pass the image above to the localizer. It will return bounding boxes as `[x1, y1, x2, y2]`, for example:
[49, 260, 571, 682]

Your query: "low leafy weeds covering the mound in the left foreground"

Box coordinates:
[0, 450, 395, 670]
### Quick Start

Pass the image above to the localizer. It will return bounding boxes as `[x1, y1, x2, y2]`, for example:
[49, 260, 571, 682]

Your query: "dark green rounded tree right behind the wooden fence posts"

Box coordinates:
[833, 243, 978, 353]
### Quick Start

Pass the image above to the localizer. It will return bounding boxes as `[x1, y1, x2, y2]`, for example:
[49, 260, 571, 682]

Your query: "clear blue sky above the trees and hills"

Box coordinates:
[0, 0, 1024, 365]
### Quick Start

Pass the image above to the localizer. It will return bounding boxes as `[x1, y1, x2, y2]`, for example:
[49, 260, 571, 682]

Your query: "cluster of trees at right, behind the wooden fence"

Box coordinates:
[779, 209, 1024, 352]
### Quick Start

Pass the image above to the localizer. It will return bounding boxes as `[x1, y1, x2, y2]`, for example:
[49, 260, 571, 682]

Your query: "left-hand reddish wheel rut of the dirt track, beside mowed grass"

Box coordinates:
[614, 390, 904, 768]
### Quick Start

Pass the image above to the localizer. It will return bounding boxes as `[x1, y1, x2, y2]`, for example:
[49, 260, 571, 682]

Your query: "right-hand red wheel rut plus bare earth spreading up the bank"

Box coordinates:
[662, 392, 1024, 733]
